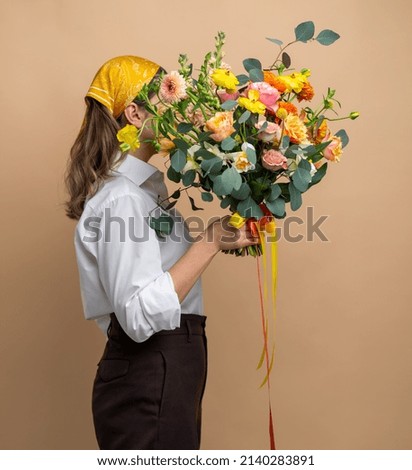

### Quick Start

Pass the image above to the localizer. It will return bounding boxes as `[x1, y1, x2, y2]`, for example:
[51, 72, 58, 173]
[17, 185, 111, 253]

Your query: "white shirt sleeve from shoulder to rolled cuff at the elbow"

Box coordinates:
[96, 194, 181, 342]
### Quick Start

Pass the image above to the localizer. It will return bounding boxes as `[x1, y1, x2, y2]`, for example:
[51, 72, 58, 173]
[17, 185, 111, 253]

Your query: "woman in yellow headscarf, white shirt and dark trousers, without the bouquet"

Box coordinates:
[66, 56, 259, 449]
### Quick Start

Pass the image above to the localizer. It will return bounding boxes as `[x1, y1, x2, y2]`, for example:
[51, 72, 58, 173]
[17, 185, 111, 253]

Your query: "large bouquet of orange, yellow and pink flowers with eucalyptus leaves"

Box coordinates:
[119, 21, 358, 256]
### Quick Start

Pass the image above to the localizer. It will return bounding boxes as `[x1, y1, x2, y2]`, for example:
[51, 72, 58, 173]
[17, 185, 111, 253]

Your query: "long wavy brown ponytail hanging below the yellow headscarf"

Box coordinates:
[64, 97, 126, 220]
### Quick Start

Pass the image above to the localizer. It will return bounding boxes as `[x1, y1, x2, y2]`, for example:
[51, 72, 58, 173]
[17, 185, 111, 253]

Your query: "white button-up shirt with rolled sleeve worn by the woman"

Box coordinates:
[74, 155, 204, 342]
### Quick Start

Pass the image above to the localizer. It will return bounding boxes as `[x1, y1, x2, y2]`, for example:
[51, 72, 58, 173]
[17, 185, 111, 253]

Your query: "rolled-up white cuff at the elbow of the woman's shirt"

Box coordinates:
[139, 271, 182, 332]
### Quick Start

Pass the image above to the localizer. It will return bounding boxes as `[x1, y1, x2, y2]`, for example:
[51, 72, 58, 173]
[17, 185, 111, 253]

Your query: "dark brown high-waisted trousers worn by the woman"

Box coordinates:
[92, 313, 207, 450]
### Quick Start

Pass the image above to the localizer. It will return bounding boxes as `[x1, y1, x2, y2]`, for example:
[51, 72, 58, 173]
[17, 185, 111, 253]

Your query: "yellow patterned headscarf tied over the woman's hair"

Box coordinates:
[86, 55, 159, 118]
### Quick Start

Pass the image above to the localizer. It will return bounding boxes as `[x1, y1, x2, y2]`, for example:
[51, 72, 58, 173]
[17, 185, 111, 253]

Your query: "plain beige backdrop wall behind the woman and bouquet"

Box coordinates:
[0, 0, 412, 449]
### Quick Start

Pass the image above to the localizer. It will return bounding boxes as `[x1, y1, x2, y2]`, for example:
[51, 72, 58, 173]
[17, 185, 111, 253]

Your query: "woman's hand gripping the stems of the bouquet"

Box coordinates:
[203, 215, 260, 251]
